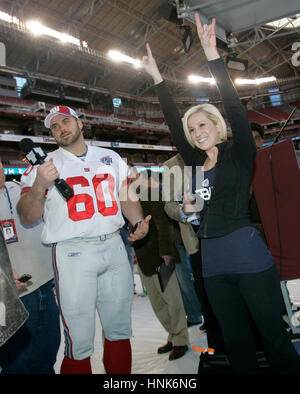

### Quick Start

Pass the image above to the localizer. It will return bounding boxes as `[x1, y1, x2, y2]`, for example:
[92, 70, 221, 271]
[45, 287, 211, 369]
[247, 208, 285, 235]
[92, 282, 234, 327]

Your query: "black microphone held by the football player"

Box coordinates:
[19, 138, 74, 200]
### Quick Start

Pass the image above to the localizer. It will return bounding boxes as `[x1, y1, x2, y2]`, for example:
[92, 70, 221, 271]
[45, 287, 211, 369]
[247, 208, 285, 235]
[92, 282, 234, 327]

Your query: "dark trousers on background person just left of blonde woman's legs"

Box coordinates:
[190, 250, 225, 353]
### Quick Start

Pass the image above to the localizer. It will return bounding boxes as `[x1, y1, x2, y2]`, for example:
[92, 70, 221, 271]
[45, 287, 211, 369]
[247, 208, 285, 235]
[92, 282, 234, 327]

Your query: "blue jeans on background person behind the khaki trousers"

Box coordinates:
[176, 245, 202, 323]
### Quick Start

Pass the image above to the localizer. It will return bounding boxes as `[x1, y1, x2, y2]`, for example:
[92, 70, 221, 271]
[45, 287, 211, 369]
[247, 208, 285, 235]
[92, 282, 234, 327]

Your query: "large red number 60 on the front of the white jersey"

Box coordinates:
[66, 174, 119, 222]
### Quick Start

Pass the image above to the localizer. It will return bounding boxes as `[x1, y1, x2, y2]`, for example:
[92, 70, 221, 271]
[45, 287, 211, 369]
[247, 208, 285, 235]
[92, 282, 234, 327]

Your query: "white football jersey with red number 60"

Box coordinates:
[21, 146, 129, 243]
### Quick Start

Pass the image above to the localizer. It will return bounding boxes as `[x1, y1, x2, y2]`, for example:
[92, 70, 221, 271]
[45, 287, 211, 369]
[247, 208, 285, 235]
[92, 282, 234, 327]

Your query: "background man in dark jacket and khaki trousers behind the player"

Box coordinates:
[134, 170, 189, 360]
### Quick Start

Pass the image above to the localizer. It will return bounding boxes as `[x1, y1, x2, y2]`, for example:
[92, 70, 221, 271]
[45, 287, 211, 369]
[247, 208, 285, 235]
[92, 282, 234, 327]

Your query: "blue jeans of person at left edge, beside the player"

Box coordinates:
[0, 281, 60, 374]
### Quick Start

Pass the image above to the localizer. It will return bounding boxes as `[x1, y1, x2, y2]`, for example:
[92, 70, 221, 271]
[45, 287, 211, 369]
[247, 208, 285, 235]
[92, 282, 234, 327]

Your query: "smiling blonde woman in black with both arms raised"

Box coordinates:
[142, 13, 300, 374]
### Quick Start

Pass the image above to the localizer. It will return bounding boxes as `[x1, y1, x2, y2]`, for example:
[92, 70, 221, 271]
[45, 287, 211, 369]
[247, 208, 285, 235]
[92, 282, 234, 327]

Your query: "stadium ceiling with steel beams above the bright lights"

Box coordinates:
[0, 0, 300, 98]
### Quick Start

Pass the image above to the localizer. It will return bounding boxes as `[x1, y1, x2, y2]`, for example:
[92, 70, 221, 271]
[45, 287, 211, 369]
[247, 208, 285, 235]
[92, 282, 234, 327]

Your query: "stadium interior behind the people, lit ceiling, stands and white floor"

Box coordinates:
[0, 0, 300, 374]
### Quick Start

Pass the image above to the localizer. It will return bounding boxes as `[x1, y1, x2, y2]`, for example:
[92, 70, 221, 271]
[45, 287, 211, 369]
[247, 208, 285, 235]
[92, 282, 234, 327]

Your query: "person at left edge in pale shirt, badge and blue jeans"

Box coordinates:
[0, 162, 60, 374]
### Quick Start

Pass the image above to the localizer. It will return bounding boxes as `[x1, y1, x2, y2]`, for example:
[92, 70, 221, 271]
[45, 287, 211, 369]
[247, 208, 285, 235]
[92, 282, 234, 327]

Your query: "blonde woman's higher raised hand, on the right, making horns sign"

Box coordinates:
[195, 12, 220, 60]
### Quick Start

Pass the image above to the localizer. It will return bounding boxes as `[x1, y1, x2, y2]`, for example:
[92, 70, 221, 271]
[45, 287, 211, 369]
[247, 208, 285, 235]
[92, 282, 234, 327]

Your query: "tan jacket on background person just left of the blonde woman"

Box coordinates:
[164, 153, 199, 255]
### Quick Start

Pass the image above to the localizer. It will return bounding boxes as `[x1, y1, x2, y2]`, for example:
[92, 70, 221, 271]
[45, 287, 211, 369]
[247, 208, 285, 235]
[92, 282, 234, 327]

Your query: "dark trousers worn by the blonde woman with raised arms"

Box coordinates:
[204, 265, 300, 374]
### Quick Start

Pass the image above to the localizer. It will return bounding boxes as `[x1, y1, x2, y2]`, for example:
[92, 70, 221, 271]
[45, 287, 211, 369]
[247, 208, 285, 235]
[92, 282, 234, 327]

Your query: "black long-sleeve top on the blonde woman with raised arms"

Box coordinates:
[156, 58, 256, 238]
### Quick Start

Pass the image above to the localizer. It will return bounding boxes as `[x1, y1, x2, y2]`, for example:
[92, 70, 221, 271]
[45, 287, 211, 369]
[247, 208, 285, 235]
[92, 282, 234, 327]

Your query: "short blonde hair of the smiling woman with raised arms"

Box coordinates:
[182, 104, 227, 147]
